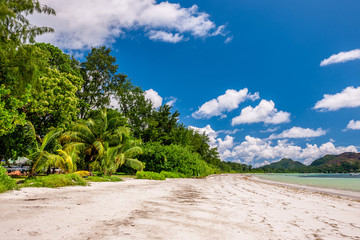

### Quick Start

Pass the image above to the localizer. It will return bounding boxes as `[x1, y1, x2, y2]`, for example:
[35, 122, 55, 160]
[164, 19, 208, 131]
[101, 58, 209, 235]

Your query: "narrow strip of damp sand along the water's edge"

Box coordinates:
[250, 175, 360, 201]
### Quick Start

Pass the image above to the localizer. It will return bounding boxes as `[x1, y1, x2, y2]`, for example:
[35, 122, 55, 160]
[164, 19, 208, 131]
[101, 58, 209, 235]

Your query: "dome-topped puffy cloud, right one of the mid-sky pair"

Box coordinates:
[231, 100, 290, 126]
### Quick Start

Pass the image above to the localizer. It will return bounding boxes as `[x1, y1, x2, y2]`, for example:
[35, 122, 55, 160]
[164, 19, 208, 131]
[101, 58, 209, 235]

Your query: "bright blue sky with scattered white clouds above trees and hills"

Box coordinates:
[32, 0, 360, 166]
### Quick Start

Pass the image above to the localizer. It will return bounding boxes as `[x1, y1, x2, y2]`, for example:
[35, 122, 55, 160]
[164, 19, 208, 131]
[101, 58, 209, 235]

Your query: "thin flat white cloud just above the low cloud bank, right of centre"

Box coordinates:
[269, 127, 326, 139]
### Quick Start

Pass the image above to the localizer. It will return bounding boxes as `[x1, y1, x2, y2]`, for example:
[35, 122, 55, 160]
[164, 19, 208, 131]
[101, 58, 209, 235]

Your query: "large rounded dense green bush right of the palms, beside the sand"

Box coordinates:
[139, 142, 215, 177]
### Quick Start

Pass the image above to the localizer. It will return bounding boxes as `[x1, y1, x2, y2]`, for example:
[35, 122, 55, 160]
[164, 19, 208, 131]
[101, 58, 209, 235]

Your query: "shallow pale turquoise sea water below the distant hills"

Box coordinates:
[256, 173, 360, 192]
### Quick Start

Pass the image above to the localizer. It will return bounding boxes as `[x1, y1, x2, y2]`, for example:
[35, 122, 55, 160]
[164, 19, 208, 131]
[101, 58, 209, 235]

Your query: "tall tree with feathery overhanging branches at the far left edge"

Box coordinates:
[0, 0, 55, 136]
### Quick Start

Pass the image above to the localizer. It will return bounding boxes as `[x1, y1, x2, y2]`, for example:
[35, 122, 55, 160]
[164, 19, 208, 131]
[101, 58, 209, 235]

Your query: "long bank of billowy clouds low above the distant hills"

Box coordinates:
[222, 136, 357, 164]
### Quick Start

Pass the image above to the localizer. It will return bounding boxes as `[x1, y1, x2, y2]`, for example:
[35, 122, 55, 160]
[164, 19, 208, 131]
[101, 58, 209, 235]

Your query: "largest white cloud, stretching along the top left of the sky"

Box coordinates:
[31, 0, 224, 50]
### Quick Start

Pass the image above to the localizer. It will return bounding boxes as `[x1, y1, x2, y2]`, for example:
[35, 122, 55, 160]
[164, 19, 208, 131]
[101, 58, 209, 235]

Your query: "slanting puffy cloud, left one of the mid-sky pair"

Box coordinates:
[191, 88, 259, 119]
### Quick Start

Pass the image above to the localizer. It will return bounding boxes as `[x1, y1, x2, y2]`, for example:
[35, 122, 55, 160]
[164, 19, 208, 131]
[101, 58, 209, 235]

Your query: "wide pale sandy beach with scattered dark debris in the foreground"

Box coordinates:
[0, 174, 360, 240]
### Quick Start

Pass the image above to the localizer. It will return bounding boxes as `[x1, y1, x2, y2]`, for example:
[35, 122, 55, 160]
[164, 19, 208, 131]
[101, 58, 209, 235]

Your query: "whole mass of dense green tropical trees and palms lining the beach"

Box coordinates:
[0, 0, 236, 191]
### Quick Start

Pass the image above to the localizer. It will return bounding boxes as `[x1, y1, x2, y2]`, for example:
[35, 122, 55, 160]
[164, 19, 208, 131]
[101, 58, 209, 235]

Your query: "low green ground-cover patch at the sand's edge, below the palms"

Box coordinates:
[22, 173, 87, 188]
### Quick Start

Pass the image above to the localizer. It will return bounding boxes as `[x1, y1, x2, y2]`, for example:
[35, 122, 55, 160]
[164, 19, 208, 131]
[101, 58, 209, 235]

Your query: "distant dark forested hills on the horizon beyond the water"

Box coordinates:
[258, 152, 360, 173]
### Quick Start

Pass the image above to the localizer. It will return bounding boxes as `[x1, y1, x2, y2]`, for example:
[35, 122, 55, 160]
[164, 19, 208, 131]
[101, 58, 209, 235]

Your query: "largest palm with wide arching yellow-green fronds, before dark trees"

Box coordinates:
[61, 109, 142, 173]
